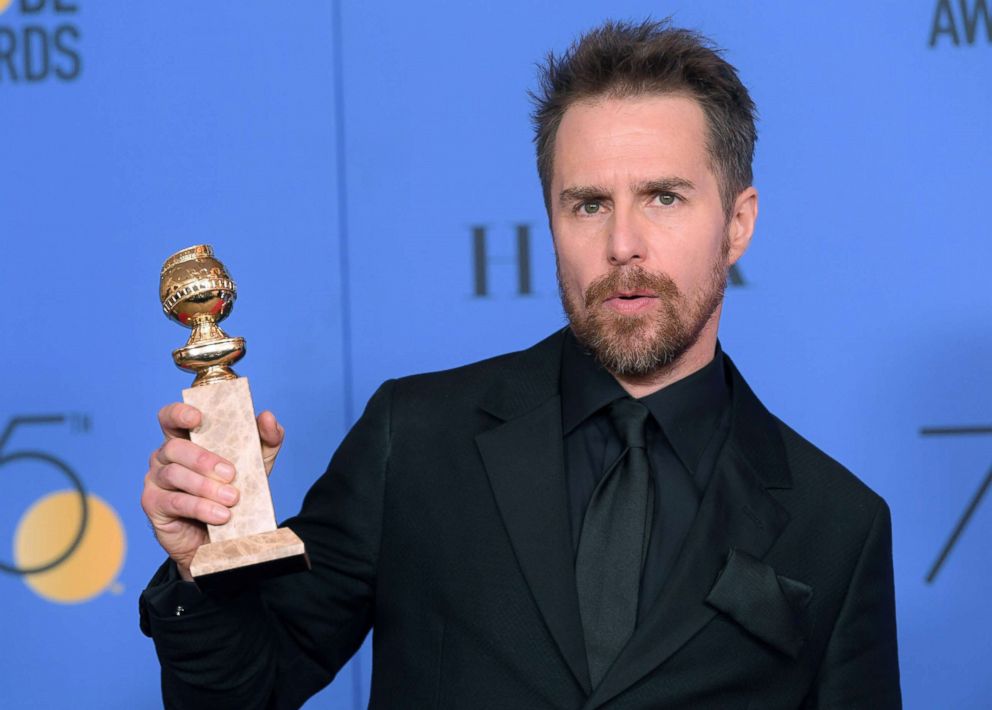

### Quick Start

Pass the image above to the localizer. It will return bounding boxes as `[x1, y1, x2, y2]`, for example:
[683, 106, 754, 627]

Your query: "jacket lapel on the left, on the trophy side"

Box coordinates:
[476, 334, 590, 693]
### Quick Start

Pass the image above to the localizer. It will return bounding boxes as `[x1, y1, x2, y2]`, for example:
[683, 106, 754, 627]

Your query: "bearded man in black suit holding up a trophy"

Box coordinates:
[142, 23, 900, 710]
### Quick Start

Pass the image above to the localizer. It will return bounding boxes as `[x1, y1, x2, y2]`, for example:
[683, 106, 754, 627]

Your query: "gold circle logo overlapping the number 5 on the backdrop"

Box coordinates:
[14, 496, 125, 604]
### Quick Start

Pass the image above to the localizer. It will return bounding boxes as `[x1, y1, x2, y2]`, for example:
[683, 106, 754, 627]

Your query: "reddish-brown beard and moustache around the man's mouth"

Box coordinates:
[558, 253, 729, 378]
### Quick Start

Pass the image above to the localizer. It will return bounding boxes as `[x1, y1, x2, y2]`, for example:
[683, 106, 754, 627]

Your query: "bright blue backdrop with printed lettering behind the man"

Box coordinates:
[0, 0, 992, 710]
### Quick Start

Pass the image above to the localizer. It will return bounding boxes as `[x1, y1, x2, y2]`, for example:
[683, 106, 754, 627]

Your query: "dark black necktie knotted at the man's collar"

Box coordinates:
[575, 397, 651, 687]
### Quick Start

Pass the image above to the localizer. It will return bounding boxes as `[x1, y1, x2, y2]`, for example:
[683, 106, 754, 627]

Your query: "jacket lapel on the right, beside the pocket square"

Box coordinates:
[583, 358, 791, 710]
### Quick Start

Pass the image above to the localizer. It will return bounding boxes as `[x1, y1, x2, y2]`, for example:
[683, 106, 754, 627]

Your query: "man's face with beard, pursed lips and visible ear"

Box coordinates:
[550, 95, 757, 378]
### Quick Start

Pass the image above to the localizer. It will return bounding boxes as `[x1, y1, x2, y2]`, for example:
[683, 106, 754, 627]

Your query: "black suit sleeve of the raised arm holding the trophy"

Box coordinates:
[140, 382, 392, 710]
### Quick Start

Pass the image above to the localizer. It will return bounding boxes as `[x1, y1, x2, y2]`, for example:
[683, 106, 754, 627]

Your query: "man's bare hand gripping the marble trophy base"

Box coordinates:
[141, 403, 286, 581]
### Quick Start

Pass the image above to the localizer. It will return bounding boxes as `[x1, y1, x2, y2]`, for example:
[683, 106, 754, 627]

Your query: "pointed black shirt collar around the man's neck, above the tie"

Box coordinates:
[561, 329, 730, 471]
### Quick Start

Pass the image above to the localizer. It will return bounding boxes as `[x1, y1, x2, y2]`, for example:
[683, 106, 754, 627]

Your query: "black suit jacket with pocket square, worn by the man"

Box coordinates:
[142, 333, 901, 710]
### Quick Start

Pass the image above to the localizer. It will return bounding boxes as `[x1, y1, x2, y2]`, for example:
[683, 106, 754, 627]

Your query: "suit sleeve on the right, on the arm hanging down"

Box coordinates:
[806, 501, 902, 710]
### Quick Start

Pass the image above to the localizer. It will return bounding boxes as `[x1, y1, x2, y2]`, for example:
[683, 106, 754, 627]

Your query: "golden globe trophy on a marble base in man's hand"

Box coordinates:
[159, 244, 310, 590]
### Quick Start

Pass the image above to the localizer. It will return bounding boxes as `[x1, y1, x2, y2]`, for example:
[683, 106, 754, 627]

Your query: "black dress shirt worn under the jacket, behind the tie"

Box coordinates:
[561, 332, 731, 620]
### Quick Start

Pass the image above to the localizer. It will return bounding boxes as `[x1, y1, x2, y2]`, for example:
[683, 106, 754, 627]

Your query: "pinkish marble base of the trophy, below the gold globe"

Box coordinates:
[183, 377, 310, 591]
